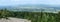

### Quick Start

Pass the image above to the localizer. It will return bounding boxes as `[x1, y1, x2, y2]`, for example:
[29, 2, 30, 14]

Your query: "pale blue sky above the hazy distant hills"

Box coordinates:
[0, 0, 60, 6]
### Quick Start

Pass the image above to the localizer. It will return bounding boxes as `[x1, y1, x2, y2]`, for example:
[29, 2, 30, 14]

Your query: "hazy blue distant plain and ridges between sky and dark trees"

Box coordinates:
[0, 4, 60, 11]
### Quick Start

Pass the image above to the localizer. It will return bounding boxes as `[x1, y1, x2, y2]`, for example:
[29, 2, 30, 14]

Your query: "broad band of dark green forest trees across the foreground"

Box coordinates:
[0, 9, 60, 22]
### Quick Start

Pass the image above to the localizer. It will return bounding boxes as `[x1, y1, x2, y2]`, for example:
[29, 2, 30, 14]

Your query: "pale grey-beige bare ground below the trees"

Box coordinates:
[0, 17, 31, 22]
